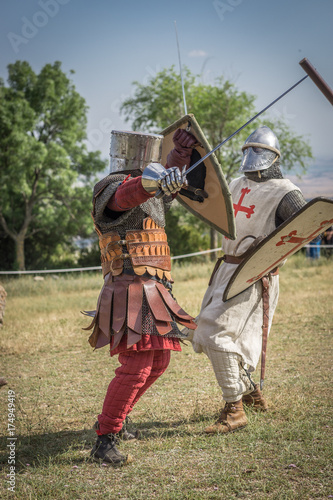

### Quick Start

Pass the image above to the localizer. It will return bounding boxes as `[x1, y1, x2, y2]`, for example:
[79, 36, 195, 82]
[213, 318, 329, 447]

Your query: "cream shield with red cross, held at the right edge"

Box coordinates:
[223, 198, 333, 302]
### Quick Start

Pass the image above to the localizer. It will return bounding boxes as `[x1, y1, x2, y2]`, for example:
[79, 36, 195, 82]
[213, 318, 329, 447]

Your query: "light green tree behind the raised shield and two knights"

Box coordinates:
[121, 66, 312, 251]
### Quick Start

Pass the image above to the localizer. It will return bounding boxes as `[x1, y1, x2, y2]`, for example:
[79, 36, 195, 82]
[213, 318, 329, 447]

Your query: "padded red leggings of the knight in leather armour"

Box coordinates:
[97, 349, 170, 435]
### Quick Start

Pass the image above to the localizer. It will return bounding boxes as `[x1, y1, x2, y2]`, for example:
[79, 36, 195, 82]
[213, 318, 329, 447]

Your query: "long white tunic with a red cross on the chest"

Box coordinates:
[192, 176, 298, 371]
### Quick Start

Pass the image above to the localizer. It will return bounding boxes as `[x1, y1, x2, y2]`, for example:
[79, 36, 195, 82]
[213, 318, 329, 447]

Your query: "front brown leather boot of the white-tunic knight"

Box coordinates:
[205, 399, 247, 434]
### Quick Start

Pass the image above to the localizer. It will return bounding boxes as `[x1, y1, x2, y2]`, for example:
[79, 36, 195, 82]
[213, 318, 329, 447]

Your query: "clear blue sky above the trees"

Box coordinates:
[0, 0, 333, 197]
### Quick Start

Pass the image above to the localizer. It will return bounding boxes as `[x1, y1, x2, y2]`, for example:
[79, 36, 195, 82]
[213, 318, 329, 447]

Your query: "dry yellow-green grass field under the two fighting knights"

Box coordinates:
[0, 254, 333, 500]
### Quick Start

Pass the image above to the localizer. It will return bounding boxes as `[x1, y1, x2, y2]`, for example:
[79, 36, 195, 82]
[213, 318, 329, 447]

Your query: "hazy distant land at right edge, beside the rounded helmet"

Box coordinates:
[284, 159, 333, 201]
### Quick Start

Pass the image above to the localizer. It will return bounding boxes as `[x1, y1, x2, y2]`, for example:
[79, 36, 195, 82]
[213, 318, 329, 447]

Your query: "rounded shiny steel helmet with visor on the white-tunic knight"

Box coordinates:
[239, 125, 281, 172]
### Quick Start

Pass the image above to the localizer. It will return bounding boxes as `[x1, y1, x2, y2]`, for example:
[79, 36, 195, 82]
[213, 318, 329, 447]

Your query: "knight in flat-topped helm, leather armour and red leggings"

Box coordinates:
[86, 131, 196, 466]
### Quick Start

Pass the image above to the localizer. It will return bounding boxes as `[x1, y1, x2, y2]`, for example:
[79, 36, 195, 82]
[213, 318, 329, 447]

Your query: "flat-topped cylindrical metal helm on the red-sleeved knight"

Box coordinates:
[110, 130, 163, 174]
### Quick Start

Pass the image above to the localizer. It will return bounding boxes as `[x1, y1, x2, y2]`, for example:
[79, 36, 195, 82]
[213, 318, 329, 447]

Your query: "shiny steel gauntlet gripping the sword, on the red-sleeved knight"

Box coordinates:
[141, 163, 187, 195]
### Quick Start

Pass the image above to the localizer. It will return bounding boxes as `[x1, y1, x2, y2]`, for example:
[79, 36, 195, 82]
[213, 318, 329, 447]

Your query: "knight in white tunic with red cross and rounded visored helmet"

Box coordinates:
[187, 126, 306, 434]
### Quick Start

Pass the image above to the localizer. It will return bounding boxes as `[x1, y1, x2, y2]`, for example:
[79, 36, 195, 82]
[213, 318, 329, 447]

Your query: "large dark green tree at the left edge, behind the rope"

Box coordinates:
[0, 61, 105, 270]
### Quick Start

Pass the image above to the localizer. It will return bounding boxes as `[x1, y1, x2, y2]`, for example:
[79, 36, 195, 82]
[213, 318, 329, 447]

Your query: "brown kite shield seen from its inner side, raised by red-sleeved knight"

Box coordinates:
[161, 114, 236, 240]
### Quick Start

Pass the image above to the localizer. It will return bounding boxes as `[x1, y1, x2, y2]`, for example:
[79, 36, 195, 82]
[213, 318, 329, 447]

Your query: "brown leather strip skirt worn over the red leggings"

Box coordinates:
[84, 273, 196, 349]
